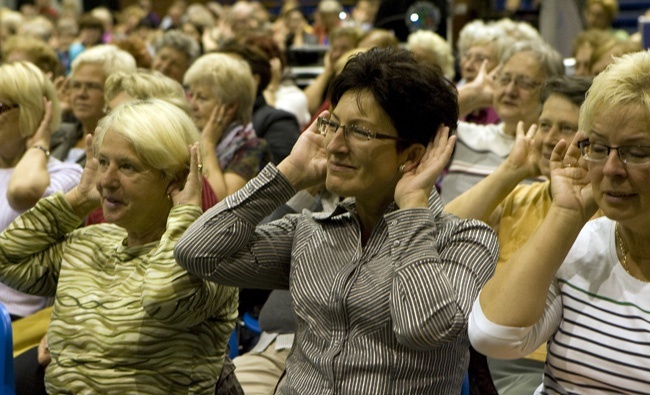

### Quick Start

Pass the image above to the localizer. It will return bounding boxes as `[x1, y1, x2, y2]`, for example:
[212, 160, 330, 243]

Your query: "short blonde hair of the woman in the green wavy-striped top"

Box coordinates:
[93, 99, 199, 178]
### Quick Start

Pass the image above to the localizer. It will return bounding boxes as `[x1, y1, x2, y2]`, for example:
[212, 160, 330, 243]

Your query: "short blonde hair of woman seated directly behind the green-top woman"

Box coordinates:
[183, 53, 255, 124]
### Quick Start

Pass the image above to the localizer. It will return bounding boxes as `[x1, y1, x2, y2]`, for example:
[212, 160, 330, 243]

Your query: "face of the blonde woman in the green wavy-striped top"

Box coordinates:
[97, 129, 172, 237]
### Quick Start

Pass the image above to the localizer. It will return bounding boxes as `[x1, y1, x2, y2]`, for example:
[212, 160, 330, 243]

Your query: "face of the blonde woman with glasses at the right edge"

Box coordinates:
[588, 105, 650, 229]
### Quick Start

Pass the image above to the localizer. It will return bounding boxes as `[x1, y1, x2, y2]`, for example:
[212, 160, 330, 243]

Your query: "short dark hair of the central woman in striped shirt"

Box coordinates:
[329, 48, 458, 151]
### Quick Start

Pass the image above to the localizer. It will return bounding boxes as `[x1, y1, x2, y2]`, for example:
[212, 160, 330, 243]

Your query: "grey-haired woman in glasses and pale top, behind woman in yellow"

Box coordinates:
[440, 40, 564, 203]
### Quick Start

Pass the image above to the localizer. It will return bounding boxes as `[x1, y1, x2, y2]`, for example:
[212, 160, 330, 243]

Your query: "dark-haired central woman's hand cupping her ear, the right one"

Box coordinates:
[395, 125, 456, 209]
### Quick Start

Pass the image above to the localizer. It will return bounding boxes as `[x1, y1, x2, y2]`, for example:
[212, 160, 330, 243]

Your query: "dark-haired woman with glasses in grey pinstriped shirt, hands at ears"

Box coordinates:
[175, 49, 497, 394]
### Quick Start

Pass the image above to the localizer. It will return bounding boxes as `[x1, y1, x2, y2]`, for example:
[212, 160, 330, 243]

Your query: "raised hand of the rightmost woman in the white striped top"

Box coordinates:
[550, 131, 598, 221]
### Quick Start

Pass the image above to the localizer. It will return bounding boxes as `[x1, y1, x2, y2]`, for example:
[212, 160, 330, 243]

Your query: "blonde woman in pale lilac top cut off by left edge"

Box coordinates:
[0, 62, 81, 319]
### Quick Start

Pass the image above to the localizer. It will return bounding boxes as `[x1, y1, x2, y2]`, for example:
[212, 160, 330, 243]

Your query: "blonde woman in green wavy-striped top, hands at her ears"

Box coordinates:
[0, 100, 237, 394]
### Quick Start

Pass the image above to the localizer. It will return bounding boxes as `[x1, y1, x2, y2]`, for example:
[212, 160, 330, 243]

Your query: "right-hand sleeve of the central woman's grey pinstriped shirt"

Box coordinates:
[386, 209, 498, 350]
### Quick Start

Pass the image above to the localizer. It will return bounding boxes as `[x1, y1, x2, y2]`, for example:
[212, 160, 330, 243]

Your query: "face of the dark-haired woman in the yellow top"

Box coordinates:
[535, 93, 580, 177]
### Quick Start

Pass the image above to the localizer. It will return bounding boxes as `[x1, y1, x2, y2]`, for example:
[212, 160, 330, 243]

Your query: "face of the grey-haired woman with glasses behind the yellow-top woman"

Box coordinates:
[494, 52, 545, 125]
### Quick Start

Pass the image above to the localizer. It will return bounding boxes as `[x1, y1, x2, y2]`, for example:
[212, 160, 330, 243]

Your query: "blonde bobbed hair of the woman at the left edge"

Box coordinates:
[0, 62, 61, 137]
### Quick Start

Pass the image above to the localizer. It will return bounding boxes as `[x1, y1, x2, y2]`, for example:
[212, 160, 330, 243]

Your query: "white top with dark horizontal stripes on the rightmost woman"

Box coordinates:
[470, 217, 650, 394]
